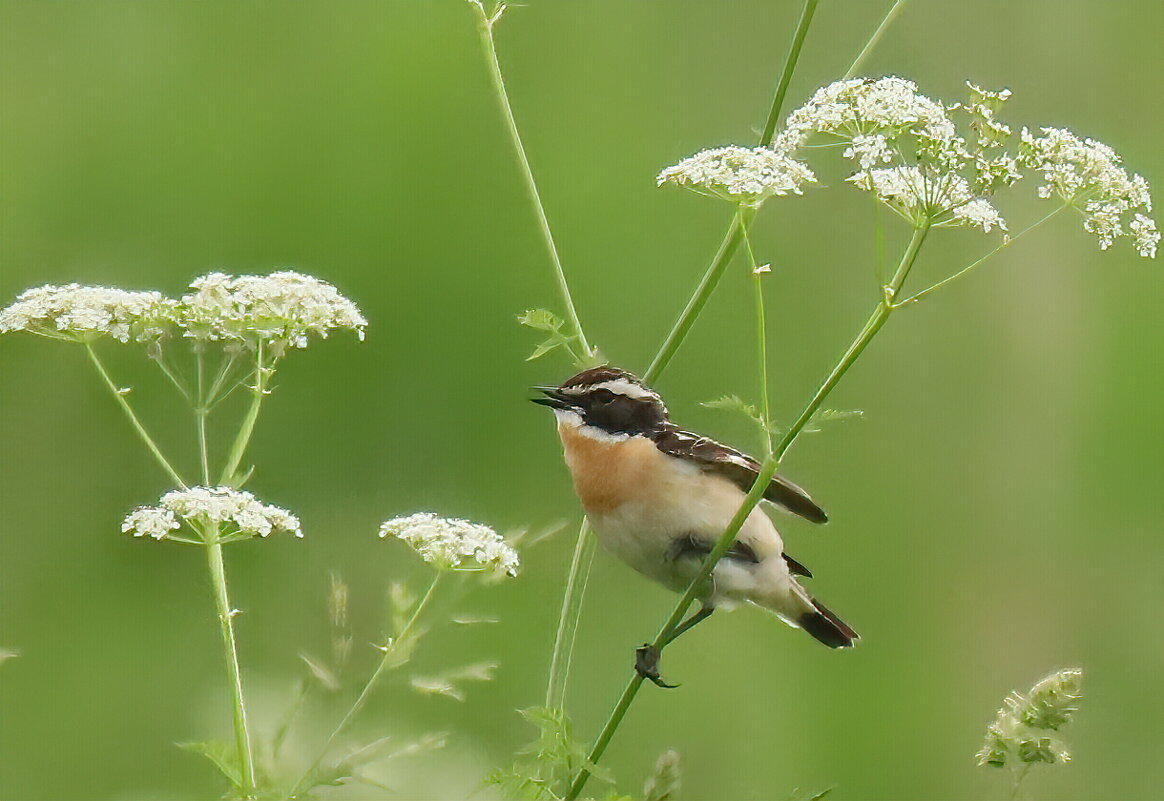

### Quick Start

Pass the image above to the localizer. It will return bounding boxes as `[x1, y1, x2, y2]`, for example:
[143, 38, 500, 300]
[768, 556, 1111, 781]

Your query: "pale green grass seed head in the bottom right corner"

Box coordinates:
[978, 667, 1084, 767]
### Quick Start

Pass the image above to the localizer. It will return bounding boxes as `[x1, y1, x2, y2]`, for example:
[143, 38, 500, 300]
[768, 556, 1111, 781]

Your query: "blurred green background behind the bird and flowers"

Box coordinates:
[0, 0, 1164, 800]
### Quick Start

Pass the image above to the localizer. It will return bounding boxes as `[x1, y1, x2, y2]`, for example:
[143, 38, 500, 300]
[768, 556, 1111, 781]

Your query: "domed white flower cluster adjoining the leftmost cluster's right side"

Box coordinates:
[179, 270, 368, 355]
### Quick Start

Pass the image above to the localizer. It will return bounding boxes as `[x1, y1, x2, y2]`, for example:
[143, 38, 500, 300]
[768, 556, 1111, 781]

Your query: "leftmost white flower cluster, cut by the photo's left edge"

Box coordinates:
[0, 284, 175, 342]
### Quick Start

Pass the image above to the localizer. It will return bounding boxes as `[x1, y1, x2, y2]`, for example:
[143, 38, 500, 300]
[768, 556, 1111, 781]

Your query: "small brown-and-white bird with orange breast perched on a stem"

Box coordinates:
[532, 364, 859, 686]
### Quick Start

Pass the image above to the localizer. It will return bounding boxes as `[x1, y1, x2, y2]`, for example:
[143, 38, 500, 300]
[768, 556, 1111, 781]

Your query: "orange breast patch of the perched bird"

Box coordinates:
[558, 424, 663, 515]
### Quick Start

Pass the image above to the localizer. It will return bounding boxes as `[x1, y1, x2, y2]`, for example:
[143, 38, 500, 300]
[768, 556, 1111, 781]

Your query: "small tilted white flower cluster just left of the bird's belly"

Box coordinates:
[379, 512, 519, 576]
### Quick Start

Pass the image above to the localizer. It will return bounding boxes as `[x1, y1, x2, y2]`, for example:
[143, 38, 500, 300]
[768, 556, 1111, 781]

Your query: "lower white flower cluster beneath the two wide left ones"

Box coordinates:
[121, 487, 303, 539]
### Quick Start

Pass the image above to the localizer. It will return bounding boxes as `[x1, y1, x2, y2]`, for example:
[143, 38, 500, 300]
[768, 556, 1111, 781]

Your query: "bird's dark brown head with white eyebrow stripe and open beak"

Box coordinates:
[533, 366, 667, 437]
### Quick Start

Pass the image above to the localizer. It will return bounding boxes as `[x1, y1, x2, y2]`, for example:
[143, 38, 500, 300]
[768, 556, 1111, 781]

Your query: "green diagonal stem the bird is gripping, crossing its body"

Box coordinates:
[566, 226, 929, 801]
